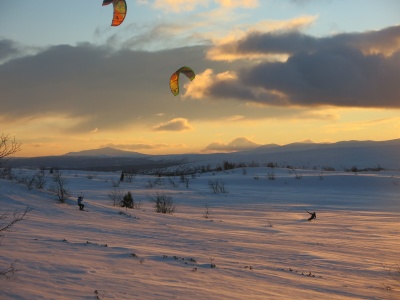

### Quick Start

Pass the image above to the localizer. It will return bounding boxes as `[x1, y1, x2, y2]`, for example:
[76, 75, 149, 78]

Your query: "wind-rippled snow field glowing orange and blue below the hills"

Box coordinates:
[0, 168, 400, 300]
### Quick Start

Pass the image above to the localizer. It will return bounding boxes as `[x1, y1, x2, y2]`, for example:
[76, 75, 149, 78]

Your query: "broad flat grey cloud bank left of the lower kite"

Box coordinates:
[0, 41, 212, 132]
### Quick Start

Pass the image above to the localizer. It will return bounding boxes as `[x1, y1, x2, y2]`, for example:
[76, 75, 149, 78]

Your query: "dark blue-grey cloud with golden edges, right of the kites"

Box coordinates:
[203, 26, 400, 108]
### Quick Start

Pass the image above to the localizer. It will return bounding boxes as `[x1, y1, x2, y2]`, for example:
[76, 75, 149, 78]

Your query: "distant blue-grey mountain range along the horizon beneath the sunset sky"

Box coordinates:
[7, 139, 400, 171]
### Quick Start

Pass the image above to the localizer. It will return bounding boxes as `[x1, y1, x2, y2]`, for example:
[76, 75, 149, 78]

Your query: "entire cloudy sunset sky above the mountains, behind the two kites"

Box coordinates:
[0, 0, 400, 156]
